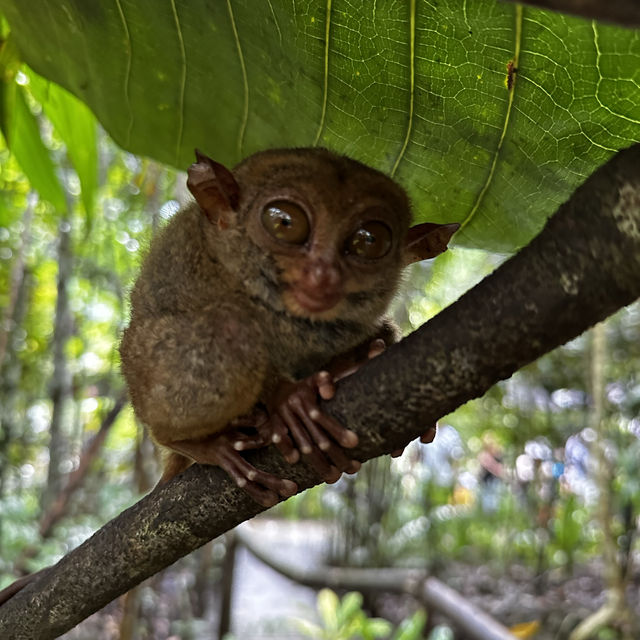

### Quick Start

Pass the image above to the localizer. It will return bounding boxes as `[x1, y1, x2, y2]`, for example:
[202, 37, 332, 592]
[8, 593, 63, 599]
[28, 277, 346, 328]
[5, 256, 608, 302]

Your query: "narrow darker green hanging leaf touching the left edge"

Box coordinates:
[0, 74, 67, 212]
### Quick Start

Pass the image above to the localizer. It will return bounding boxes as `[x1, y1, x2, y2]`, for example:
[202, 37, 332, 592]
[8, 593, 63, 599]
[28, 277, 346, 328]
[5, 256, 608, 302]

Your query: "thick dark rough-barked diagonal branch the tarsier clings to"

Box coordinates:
[0, 144, 640, 640]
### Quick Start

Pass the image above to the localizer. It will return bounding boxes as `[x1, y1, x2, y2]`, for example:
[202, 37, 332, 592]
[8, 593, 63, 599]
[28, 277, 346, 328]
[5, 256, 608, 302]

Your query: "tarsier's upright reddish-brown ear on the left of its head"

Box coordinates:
[187, 149, 240, 227]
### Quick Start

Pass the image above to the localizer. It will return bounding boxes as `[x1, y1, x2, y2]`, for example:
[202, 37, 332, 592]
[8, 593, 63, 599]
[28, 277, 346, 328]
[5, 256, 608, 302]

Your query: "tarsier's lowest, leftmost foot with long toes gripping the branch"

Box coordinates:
[171, 428, 298, 507]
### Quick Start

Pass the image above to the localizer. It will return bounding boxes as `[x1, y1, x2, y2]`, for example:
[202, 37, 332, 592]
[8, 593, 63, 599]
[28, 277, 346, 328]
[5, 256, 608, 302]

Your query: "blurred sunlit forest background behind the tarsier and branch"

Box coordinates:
[0, 6, 640, 640]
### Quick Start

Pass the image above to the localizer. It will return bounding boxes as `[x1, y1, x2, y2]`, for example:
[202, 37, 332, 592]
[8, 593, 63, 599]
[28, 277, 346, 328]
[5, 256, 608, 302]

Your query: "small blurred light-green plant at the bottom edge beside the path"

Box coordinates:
[295, 589, 426, 640]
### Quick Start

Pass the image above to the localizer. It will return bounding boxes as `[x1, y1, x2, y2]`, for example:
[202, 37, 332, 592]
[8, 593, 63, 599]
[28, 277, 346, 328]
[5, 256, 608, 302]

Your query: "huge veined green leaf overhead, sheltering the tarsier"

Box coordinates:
[0, 0, 640, 251]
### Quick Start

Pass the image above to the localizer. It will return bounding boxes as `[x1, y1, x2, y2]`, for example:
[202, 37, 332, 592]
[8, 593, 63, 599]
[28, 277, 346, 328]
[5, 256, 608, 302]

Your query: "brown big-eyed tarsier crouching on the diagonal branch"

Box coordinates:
[120, 148, 458, 506]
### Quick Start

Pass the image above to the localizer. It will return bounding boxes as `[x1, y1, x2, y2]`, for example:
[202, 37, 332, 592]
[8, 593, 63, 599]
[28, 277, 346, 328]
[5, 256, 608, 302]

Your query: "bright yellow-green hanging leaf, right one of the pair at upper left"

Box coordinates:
[29, 72, 98, 222]
